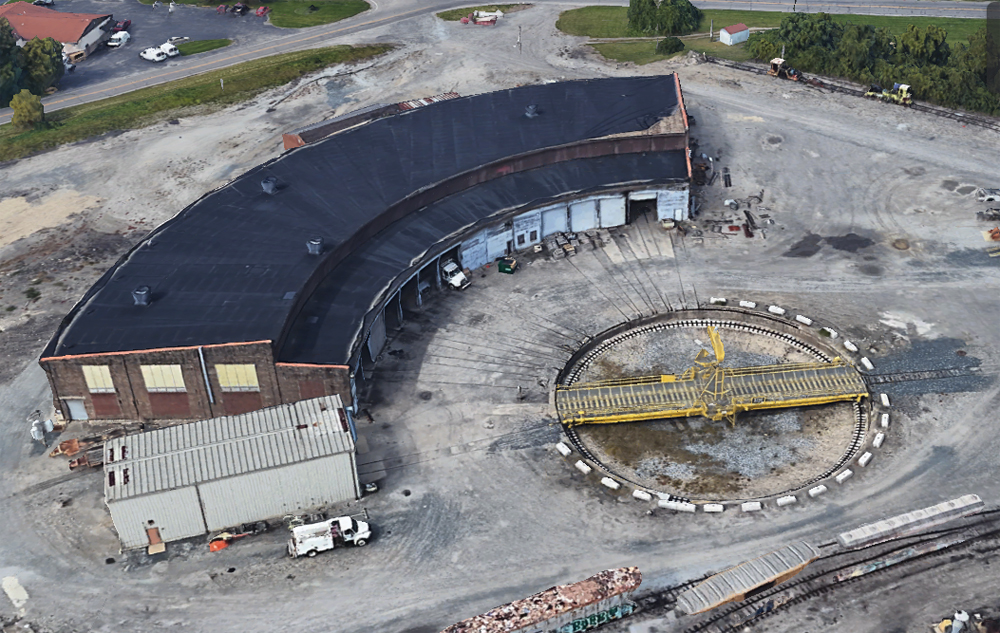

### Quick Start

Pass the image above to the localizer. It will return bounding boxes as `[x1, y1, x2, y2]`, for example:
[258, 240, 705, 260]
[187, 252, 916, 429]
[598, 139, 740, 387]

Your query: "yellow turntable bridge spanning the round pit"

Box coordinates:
[556, 327, 868, 426]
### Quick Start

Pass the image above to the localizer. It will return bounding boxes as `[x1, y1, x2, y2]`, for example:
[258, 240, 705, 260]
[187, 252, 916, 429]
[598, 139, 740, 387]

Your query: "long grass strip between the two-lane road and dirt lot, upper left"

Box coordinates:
[0, 44, 393, 160]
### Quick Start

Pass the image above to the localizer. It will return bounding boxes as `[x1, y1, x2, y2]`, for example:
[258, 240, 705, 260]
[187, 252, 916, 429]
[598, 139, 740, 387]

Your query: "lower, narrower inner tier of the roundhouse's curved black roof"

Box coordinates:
[278, 150, 687, 364]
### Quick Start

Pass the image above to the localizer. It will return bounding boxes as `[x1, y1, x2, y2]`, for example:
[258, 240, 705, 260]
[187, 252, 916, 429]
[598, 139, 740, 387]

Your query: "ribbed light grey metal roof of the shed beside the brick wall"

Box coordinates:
[104, 396, 354, 502]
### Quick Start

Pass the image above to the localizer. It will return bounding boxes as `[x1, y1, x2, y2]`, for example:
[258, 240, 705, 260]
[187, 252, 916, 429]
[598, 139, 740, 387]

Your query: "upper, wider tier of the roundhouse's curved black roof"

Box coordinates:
[42, 75, 679, 362]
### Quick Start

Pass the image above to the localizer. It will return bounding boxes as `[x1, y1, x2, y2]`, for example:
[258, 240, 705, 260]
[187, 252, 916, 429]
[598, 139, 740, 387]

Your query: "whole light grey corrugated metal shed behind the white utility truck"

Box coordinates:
[104, 396, 360, 549]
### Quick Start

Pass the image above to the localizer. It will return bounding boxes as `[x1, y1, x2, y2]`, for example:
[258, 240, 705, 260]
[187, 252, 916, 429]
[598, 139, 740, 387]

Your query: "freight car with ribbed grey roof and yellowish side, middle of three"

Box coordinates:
[677, 541, 819, 614]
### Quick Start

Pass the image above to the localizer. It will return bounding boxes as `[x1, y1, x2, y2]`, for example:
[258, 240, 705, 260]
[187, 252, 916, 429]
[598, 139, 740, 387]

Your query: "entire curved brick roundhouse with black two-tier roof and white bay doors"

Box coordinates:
[40, 75, 691, 424]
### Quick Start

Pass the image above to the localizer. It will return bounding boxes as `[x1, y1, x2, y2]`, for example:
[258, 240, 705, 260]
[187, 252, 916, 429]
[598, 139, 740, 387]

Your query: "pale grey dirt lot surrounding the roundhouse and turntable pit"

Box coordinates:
[0, 7, 1000, 633]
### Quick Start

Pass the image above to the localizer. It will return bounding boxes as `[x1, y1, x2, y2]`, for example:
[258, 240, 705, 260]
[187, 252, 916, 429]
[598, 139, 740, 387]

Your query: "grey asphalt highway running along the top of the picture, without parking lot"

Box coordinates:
[0, 0, 988, 124]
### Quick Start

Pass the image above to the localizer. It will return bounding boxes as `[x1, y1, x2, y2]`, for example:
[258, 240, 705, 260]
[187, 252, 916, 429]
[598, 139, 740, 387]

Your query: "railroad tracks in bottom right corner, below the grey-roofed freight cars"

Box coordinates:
[674, 510, 1000, 633]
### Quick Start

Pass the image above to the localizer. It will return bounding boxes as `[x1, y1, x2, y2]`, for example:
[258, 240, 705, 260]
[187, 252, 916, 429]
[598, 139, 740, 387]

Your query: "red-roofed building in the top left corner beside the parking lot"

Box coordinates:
[0, 2, 114, 56]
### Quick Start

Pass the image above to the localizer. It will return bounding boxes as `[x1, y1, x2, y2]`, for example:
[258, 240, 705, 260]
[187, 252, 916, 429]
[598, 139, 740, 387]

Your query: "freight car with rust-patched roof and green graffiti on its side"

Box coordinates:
[442, 567, 642, 633]
